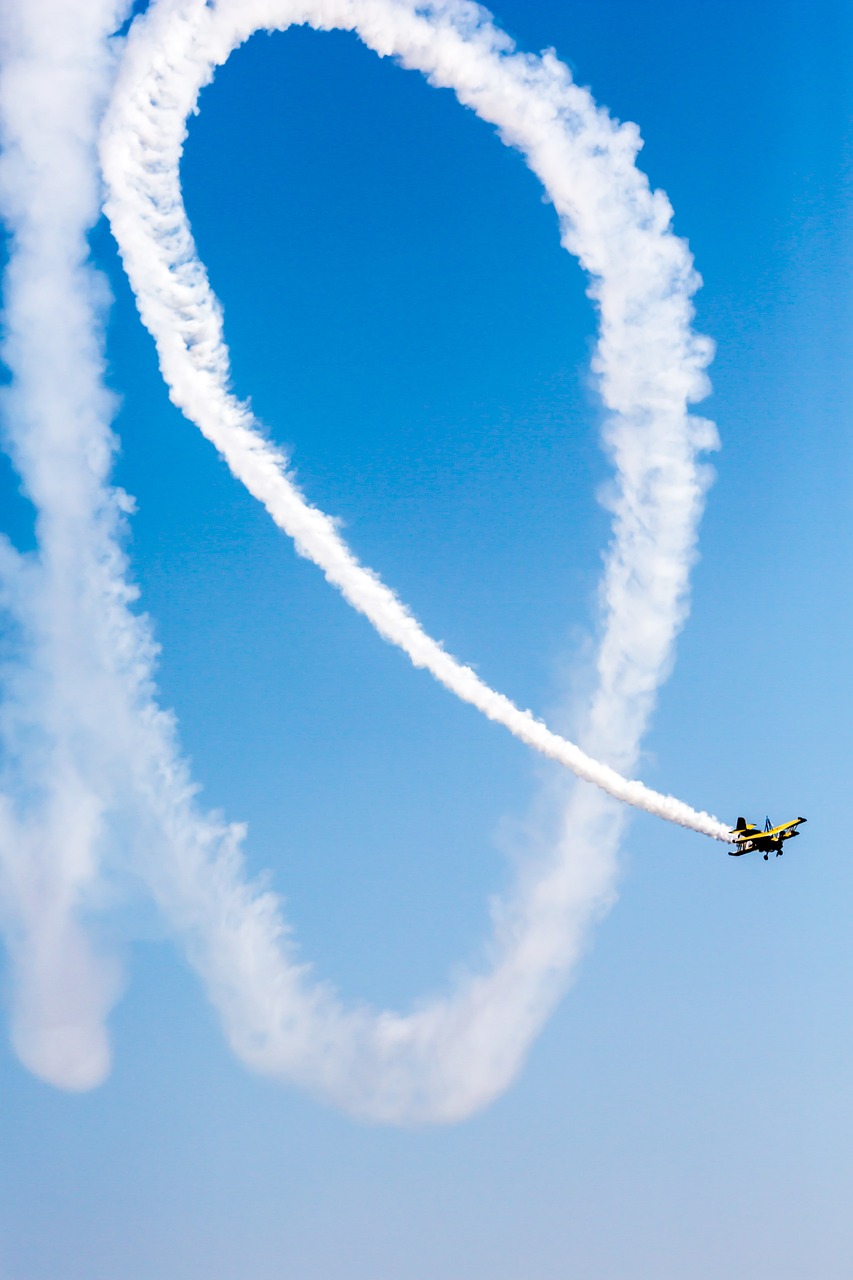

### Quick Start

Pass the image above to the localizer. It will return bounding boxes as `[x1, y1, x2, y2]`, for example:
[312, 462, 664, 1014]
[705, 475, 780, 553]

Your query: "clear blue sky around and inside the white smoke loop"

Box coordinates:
[0, 0, 853, 1280]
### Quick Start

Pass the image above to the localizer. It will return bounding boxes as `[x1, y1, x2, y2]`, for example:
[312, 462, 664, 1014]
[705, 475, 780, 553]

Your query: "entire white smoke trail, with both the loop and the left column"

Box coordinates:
[0, 0, 719, 1121]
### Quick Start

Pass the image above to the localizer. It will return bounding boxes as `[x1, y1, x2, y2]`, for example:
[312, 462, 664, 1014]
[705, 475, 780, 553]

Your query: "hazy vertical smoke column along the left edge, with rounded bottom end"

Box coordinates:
[0, 0, 142, 1088]
